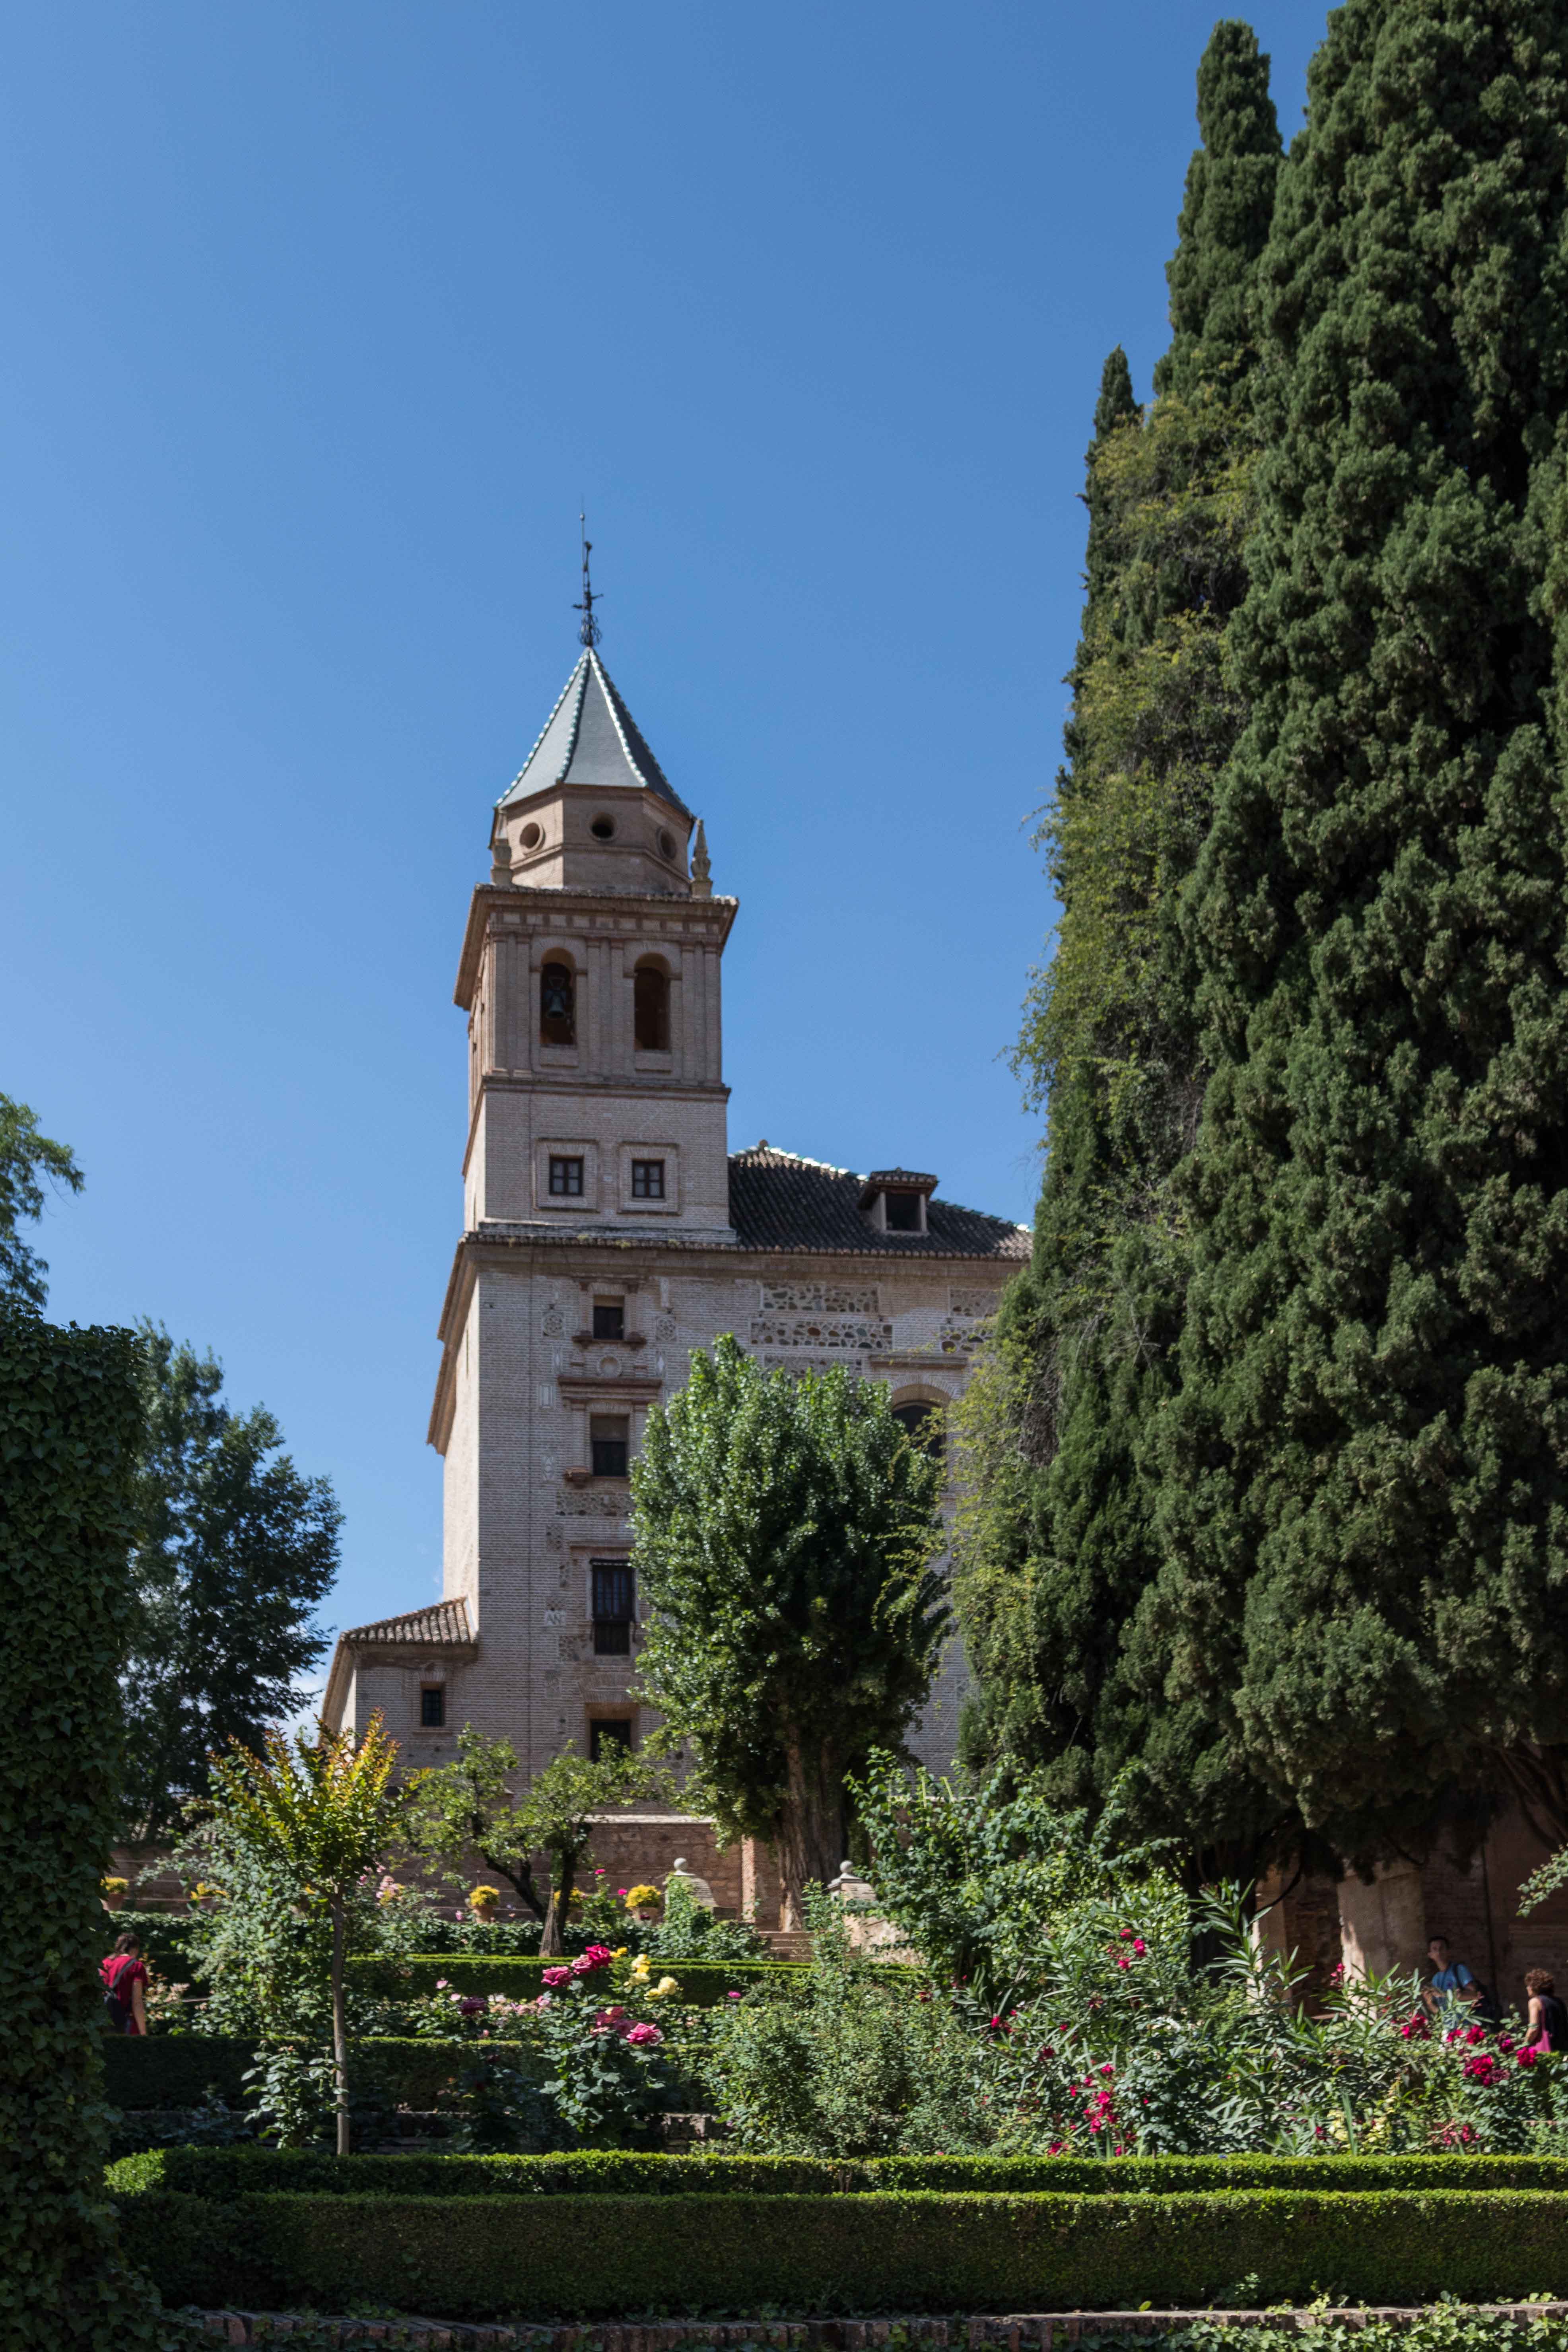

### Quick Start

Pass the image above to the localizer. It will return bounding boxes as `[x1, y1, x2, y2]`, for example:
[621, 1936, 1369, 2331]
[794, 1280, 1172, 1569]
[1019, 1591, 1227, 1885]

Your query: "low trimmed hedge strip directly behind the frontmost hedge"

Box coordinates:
[108, 2154, 1568, 2201]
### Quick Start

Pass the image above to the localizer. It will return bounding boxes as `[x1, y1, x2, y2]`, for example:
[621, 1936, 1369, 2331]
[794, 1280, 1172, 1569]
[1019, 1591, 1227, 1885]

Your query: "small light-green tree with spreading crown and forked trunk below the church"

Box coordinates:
[409, 1724, 675, 1954]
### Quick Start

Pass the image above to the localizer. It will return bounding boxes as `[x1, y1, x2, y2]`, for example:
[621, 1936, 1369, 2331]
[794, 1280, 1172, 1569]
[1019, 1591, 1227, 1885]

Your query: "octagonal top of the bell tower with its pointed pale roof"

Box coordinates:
[492, 647, 701, 899]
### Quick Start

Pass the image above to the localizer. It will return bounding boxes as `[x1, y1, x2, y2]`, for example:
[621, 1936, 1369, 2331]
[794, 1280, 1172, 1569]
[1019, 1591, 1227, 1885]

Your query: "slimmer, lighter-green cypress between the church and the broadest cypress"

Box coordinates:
[959, 21, 1281, 1849]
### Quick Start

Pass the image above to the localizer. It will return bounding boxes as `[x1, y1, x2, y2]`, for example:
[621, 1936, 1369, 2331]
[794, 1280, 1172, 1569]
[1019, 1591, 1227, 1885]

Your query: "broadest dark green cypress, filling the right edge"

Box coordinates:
[1166, 0, 1568, 1856]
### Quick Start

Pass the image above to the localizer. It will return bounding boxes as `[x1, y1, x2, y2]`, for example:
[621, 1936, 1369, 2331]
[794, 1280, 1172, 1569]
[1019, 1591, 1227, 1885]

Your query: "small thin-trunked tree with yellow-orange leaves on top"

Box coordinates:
[212, 1715, 409, 2157]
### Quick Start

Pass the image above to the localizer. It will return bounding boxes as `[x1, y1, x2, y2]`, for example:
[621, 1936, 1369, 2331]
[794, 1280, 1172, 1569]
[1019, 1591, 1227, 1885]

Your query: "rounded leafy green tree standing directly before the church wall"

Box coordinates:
[632, 1334, 947, 1926]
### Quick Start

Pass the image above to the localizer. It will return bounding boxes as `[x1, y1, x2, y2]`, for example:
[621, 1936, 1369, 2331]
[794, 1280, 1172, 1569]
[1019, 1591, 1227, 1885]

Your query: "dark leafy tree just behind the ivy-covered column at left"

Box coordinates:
[122, 1324, 341, 1844]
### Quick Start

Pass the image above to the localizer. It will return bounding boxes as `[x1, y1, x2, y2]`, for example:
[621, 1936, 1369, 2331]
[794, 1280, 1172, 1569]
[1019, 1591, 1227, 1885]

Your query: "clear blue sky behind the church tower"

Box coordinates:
[0, 0, 1321, 1656]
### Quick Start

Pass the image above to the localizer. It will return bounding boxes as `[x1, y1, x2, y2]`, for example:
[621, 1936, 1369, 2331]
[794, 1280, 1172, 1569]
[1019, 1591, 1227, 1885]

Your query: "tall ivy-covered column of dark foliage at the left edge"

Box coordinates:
[0, 1317, 165, 2352]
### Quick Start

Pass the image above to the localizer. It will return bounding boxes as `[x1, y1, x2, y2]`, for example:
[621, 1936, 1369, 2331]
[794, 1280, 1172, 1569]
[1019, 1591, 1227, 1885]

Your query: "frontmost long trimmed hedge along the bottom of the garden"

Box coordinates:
[120, 2157, 1568, 2319]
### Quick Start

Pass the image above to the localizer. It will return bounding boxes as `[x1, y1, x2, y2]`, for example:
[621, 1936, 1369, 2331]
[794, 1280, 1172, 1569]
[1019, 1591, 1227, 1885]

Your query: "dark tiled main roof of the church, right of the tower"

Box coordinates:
[729, 1143, 1030, 1259]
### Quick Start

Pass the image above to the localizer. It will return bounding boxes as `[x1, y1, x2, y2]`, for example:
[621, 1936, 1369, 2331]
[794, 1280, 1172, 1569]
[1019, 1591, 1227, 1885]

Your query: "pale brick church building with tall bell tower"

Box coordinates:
[324, 630, 1030, 1834]
